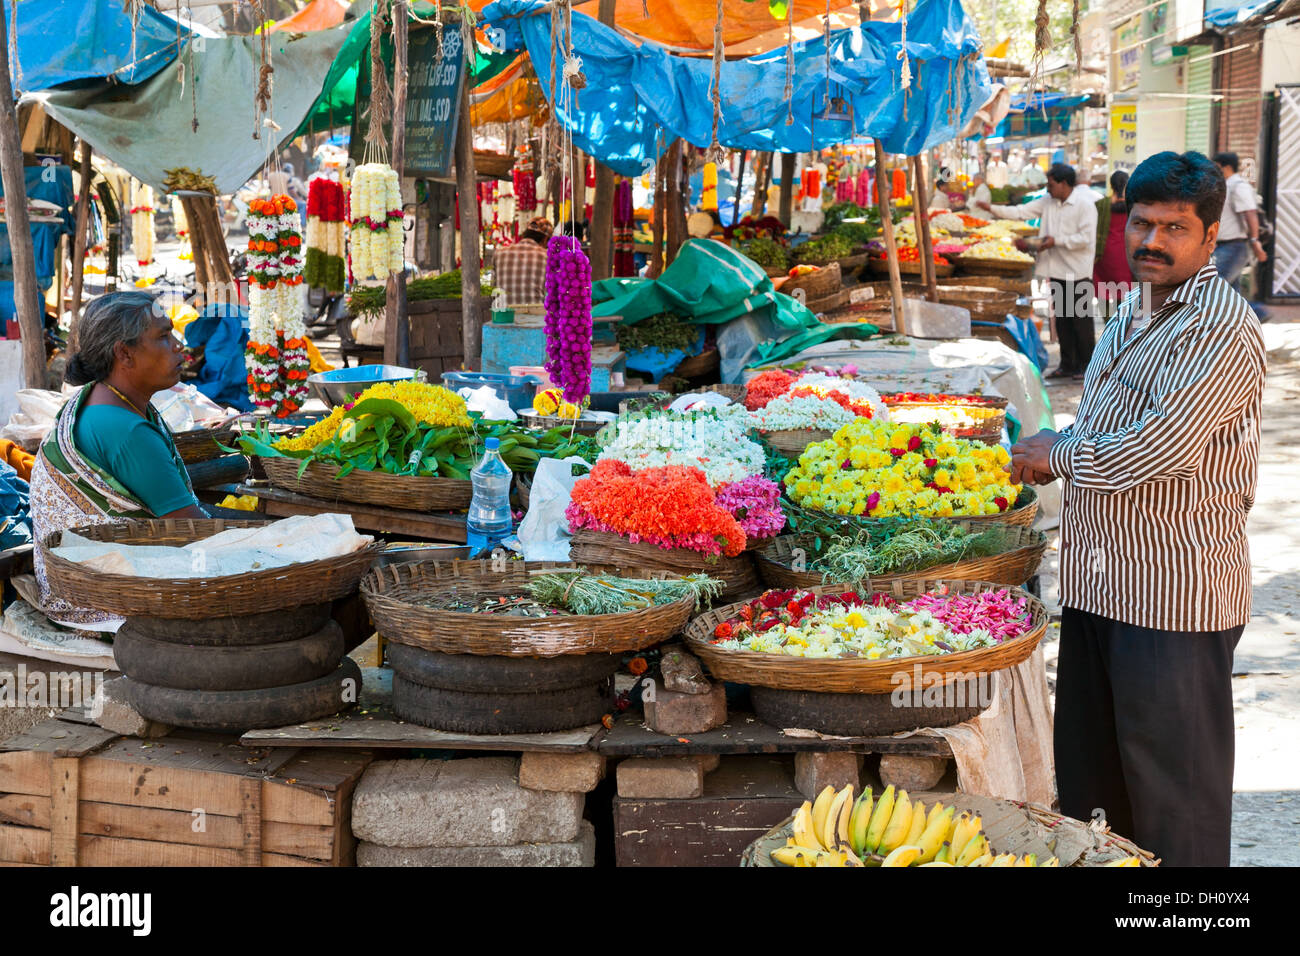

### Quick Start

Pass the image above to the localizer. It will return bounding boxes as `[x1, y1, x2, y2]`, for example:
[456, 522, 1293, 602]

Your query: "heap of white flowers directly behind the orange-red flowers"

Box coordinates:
[601, 412, 766, 488]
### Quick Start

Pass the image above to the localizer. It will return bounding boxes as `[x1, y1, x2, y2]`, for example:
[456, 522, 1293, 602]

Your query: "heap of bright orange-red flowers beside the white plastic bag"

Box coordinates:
[564, 460, 746, 558]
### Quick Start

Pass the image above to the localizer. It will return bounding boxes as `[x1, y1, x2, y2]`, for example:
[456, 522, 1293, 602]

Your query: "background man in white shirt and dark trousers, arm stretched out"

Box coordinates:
[979, 163, 1097, 380]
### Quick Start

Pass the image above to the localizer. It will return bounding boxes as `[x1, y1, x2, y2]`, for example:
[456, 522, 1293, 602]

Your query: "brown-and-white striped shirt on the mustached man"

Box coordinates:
[1049, 264, 1265, 631]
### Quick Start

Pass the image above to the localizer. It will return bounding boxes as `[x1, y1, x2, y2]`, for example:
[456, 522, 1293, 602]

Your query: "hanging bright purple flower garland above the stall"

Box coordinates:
[545, 235, 592, 405]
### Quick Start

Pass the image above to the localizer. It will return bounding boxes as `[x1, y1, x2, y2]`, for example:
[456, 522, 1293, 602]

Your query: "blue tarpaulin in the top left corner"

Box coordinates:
[0, 0, 190, 92]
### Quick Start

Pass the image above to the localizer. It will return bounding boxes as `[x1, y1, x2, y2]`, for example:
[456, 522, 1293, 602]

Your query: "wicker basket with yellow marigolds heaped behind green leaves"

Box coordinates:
[257, 381, 473, 511]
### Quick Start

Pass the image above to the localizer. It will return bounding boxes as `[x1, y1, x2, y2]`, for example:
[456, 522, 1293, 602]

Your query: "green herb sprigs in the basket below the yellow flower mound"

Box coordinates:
[781, 512, 1006, 583]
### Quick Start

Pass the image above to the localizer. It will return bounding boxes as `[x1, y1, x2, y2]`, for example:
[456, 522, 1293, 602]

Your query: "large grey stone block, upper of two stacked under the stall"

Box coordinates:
[352, 757, 584, 847]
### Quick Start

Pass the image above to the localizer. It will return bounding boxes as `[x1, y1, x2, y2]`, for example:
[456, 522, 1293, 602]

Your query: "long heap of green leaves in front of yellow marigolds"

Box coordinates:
[239, 398, 573, 480]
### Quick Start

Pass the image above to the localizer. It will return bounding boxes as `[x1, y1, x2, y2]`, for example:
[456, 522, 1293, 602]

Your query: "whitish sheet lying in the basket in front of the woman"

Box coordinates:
[53, 514, 374, 579]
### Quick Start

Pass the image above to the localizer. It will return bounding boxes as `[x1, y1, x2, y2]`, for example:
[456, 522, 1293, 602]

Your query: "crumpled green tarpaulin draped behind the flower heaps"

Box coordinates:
[592, 239, 879, 381]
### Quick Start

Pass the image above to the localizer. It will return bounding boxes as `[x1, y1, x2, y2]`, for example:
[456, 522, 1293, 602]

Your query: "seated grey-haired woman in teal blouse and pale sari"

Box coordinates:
[31, 291, 208, 627]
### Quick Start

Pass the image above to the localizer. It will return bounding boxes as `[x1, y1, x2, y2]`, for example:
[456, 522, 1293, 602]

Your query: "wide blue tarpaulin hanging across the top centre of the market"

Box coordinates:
[482, 0, 992, 176]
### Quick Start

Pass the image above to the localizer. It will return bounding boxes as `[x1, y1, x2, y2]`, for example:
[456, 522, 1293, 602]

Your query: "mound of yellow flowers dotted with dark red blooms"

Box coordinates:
[784, 419, 1021, 518]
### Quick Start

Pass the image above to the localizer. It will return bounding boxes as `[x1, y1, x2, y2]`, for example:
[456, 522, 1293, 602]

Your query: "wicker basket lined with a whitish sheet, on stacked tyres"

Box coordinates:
[42, 518, 385, 620]
